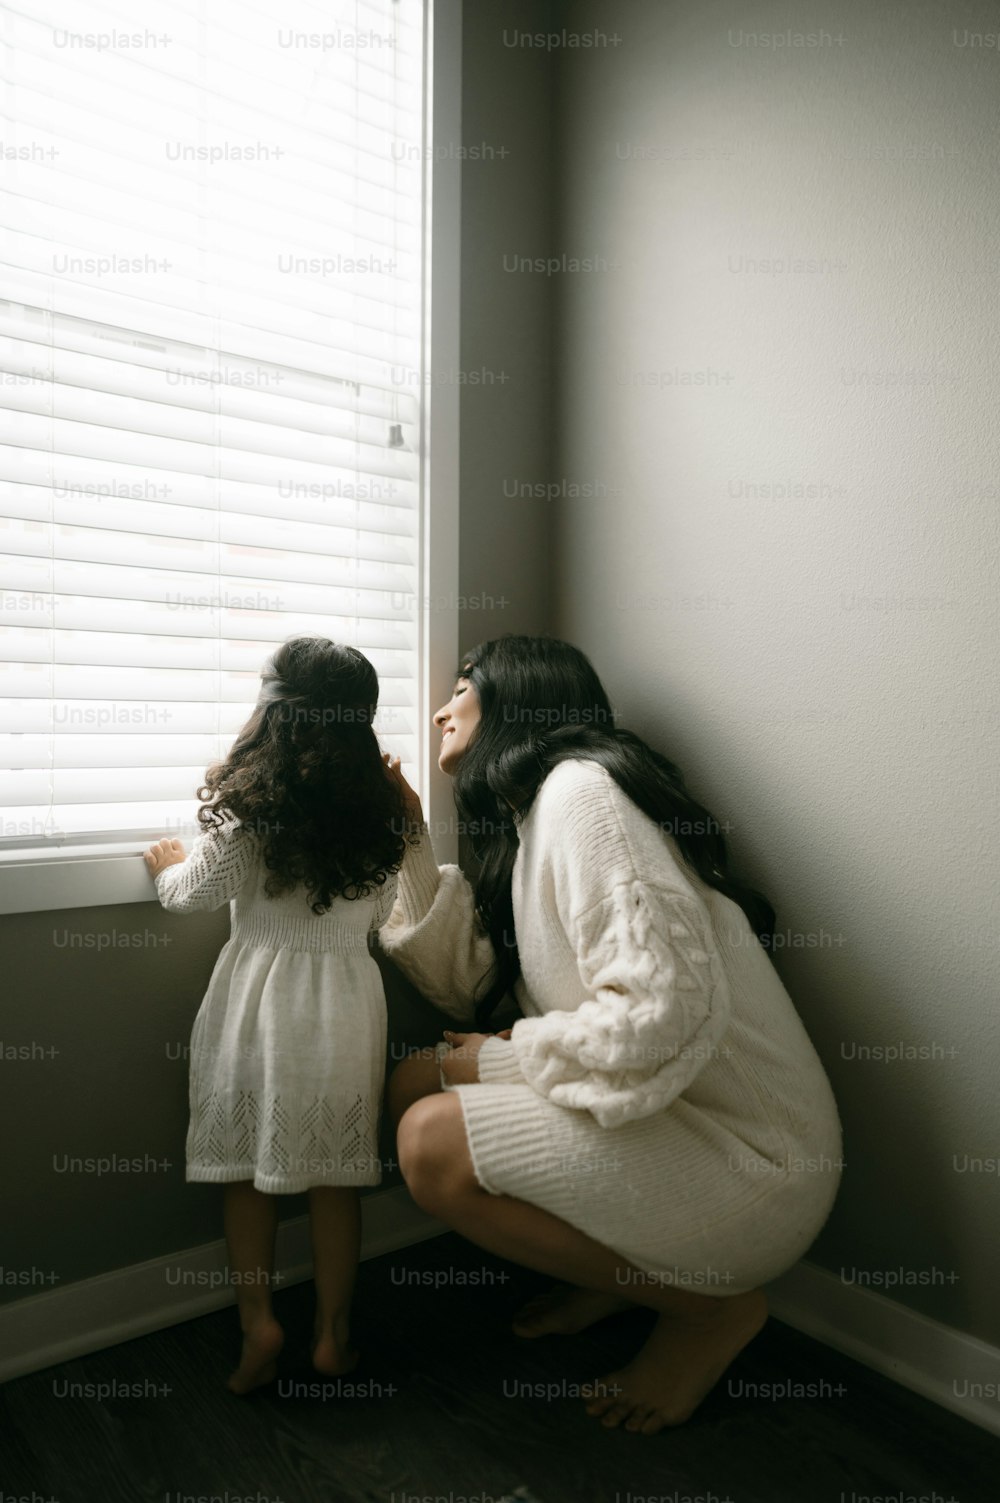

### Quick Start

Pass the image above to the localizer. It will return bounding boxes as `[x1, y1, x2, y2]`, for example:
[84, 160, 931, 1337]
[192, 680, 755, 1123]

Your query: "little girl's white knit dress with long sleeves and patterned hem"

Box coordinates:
[156, 822, 397, 1195]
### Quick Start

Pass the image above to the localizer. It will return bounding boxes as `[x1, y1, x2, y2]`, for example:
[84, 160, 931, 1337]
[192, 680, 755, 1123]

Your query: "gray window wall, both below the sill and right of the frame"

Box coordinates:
[0, 0, 550, 1302]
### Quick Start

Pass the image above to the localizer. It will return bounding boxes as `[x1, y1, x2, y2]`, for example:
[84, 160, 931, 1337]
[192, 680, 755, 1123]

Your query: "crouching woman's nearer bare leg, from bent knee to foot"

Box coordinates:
[398, 1091, 767, 1435]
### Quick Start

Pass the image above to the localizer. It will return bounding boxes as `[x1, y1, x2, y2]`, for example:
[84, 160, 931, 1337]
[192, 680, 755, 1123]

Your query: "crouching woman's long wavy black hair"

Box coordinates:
[454, 634, 774, 1024]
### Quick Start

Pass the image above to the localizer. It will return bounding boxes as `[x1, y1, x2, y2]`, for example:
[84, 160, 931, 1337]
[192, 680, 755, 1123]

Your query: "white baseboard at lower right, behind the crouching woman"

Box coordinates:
[767, 1260, 1000, 1435]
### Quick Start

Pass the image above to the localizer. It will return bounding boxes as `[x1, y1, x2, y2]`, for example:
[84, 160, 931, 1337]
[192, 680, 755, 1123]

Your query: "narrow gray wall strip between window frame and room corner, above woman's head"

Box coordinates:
[457, 0, 552, 649]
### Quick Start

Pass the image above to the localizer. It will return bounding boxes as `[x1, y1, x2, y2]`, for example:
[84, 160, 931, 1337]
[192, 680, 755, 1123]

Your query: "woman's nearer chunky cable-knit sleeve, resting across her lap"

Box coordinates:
[480, 879, 729, 1127]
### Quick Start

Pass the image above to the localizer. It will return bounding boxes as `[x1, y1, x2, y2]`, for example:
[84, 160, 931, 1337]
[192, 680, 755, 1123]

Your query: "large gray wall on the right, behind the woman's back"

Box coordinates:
[550, 0, 1000, 1342]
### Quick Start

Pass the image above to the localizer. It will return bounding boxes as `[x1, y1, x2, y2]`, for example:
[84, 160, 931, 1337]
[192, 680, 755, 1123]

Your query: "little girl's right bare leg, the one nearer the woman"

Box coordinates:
[308, 1186, 361, 1378]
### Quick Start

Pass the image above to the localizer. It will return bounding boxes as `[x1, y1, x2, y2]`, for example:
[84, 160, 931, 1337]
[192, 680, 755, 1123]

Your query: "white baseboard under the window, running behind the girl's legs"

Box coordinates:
[0, 1186, 448, 1383]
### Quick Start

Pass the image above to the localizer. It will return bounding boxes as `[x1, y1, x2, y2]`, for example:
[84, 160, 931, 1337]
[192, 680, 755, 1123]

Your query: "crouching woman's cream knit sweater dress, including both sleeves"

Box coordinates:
[380, 759, 842, 1296]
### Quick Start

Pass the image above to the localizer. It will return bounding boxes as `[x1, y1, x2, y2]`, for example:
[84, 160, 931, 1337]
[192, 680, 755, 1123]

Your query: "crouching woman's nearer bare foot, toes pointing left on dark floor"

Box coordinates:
[586, 1290, 767, 1435]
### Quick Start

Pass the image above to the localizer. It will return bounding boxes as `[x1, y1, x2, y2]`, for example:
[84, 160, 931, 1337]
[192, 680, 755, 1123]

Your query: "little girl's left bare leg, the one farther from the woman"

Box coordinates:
[223, 1180, 284, 1393]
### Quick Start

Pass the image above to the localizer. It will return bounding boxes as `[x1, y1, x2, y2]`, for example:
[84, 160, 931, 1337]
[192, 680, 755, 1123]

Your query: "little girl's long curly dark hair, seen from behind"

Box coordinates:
[198, 637, 408, 914]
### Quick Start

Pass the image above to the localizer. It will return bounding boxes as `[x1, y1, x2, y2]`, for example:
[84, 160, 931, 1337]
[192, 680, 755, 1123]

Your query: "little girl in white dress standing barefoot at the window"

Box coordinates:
[144, 637, 408, 1393]
